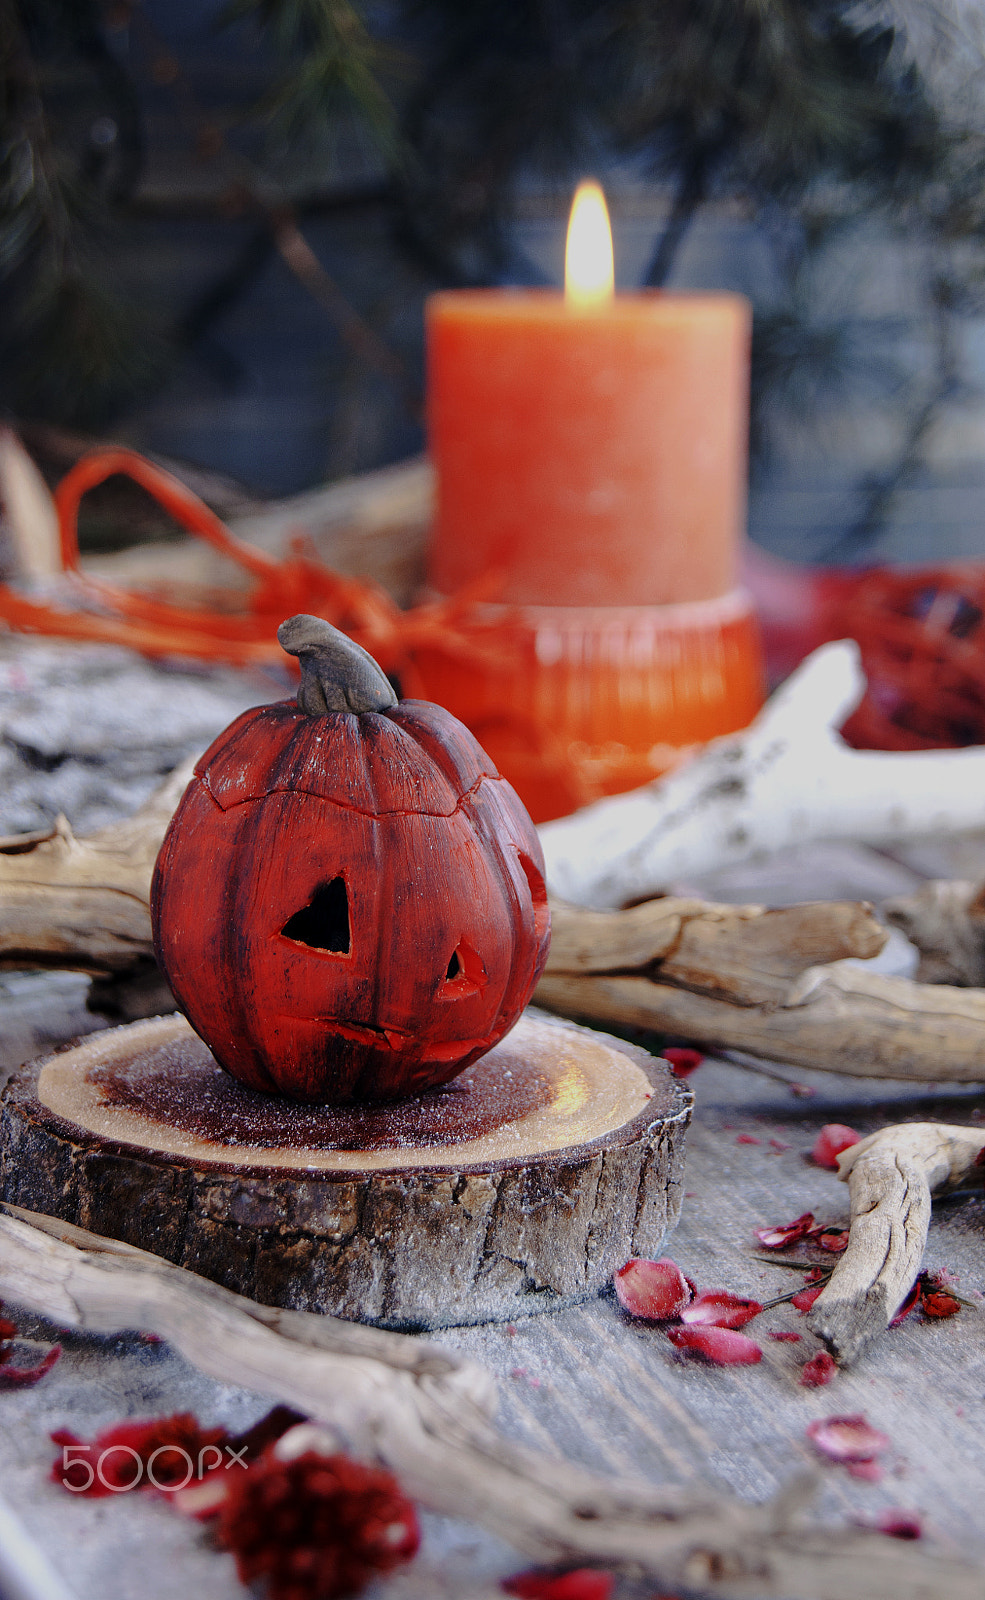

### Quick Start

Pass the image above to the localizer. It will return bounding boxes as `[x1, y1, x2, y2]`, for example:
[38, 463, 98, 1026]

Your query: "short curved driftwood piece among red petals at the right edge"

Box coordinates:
[808, 1122, 985, 1365]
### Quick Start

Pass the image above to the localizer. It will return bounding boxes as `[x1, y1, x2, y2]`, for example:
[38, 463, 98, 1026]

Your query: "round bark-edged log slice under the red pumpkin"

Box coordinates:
[0, 1013, 691, 1328]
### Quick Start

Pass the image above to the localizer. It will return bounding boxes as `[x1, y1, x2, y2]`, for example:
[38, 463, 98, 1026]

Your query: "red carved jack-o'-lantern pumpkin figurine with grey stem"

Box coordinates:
[150, 616, 550, 1104]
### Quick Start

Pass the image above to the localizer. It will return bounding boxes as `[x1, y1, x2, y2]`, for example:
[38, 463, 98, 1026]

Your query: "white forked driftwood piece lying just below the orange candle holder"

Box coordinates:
[539, 640, 985, 909]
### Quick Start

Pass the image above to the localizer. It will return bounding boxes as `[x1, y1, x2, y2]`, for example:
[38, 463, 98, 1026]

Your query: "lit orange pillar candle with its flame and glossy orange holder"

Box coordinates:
[416, 186, 763, 821]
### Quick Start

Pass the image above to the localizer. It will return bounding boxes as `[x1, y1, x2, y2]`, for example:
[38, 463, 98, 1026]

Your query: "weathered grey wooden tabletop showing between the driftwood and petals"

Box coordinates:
[0, 640, 985, 1600]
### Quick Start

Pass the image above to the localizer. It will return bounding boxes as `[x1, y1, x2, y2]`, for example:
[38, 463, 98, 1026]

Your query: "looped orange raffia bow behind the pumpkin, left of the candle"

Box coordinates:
[0, 450, 493, 693]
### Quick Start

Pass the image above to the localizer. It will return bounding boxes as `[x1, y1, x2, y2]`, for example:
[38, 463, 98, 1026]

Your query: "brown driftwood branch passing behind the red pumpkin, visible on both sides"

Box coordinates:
[0, 760, 985, 1083]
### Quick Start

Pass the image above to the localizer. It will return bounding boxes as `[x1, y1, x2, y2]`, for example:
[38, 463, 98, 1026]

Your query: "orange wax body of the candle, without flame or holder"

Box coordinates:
[427, 290, 750, 605]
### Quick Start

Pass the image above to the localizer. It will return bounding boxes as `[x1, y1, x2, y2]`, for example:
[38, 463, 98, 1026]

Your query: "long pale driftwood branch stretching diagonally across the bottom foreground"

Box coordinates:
[0, 1208, 985, 1600]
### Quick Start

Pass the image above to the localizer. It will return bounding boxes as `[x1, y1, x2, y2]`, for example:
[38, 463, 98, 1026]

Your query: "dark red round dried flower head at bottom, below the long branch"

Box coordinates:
[217, 1450, 421, 1600]
